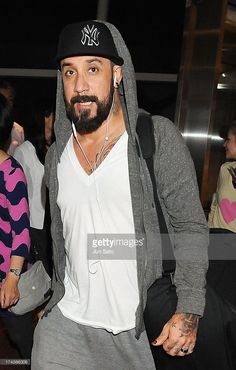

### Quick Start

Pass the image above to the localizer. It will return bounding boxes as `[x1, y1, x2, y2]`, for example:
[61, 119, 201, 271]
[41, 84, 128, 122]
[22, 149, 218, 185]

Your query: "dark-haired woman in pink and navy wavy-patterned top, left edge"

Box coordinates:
[0, 94, 34, 360]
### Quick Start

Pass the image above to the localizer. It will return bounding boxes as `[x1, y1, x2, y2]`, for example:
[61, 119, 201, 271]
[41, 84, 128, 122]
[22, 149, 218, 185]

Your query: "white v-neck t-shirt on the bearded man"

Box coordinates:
[57, 132, 139, 334]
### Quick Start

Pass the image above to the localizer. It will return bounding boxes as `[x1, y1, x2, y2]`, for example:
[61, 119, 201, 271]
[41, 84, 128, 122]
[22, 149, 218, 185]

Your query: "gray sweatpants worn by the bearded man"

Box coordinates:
[31, 306, 155, 370]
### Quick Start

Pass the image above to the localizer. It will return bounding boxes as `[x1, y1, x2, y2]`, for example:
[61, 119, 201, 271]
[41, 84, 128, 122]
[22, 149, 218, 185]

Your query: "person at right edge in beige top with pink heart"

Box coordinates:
[207, 121, 236, 310]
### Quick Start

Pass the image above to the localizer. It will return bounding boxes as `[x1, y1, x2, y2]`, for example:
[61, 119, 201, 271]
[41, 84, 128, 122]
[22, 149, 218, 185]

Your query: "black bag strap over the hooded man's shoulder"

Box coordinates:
[137, 113, 175, 274]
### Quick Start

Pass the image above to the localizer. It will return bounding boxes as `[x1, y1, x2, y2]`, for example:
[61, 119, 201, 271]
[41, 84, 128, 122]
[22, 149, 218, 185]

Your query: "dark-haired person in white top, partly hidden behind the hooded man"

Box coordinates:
[14, 99, 54, 275]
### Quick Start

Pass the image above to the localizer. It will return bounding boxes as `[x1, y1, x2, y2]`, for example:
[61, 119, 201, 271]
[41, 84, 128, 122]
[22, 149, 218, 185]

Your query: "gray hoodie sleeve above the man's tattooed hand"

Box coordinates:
[154, 117, 209, 316]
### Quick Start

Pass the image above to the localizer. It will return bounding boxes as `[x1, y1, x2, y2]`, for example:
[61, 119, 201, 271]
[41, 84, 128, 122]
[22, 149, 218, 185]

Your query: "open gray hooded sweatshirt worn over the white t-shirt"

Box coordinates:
[45, 22, 208, 338]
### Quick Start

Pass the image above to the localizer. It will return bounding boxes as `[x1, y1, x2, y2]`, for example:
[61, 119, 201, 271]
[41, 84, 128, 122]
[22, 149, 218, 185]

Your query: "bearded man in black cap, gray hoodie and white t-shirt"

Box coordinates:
[32, 21, 208, 370]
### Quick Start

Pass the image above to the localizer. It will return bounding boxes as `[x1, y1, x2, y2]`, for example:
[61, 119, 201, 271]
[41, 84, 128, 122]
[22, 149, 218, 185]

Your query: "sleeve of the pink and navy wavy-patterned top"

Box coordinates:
[6, 160, 30, 258]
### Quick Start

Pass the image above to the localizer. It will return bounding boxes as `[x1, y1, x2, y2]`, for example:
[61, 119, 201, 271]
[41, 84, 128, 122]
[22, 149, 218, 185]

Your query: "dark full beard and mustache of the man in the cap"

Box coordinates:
[65, 83, 114, 135]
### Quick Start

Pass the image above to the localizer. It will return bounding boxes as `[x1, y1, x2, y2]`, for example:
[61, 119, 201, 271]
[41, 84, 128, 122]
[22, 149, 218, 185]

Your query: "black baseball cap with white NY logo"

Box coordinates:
[56, 20, 124, 65]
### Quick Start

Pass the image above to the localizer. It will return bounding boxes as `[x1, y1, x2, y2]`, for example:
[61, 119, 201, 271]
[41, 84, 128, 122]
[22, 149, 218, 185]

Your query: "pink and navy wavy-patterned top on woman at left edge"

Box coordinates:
[0, 157, 30, 286]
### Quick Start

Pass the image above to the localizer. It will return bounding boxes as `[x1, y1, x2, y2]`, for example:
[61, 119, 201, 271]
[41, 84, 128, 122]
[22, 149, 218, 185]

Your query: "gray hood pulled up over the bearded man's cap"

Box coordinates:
[54, 20, 138, 158]
